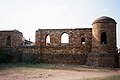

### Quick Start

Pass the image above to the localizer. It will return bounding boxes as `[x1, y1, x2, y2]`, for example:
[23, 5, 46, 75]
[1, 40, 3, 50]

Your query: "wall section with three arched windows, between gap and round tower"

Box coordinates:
[35, 28, 92, 64]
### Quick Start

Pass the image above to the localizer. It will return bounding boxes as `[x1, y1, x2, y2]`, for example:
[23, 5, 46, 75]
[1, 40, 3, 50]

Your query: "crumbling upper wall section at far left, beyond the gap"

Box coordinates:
[0, 30, 23, 48]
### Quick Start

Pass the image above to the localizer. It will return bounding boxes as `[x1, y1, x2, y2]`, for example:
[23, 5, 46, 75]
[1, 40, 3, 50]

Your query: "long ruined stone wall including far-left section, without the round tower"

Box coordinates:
[1, 28, 92, 64]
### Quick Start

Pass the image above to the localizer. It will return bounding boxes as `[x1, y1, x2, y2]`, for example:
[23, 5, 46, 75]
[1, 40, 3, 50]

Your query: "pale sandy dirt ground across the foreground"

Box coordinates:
[0, 67, 120, 80]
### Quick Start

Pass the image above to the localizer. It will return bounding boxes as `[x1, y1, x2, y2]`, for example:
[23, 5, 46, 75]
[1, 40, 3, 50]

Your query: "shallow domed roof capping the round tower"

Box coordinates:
[93, 16, 116, 24]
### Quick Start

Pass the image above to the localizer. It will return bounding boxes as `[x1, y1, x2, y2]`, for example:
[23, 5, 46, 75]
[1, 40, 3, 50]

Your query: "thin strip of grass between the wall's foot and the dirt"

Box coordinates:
[0, 63, 117, 72]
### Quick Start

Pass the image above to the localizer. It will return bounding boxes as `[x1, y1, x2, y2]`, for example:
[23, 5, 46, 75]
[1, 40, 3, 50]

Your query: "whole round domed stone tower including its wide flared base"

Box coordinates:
[87, 16, 117, 67]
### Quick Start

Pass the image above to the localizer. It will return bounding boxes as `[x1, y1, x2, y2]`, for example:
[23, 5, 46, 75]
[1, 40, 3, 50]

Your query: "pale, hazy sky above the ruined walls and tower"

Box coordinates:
[0, 0, 120, 48]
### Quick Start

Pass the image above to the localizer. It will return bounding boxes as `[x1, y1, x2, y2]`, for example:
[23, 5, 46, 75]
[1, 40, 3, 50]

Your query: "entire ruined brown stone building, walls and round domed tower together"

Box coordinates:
[0, 16, 119, 67]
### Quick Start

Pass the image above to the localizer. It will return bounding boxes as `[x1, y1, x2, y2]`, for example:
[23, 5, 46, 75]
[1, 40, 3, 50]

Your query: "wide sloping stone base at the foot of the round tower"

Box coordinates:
[86, 52, 119, 67]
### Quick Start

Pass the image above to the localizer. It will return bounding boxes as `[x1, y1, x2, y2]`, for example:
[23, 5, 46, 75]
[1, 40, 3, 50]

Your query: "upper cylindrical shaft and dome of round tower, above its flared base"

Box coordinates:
[92, 16, 116, 53]
